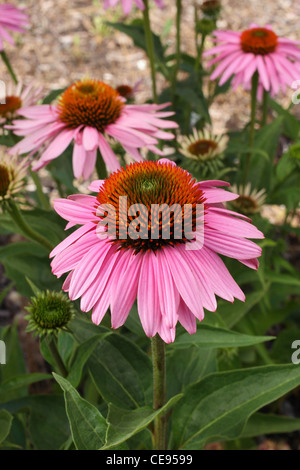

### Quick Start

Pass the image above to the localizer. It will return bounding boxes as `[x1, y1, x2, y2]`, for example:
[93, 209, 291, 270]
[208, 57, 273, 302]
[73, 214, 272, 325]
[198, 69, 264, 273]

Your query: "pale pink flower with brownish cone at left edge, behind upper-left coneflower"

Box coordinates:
[0, 82, 43, 124]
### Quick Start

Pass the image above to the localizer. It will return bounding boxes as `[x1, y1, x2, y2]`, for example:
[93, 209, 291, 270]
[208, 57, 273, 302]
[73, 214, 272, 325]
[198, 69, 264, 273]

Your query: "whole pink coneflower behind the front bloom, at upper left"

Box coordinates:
[7, 79, 178, 179]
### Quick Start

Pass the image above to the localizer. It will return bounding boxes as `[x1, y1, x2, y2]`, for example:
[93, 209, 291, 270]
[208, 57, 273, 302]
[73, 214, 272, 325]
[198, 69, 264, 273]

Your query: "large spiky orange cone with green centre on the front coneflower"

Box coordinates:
[97, 161, 205, 253]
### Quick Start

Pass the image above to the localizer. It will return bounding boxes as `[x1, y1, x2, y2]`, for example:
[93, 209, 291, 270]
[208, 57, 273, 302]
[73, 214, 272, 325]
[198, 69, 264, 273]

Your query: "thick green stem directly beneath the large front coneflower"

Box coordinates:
[151, 335, 167, 450]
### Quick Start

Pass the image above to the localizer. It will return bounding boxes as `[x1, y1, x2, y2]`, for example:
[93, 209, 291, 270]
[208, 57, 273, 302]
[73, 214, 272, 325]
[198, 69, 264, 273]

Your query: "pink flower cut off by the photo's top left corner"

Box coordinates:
[0, 3, 29, 51]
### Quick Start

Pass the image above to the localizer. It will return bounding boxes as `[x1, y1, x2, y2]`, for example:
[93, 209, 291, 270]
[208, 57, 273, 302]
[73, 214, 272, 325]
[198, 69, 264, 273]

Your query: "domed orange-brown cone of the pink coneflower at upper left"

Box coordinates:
[57, 79, 124, 132]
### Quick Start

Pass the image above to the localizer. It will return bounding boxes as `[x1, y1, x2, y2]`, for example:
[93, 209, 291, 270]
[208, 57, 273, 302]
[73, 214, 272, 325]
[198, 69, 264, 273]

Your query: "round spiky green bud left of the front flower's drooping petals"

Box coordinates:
[25, 290, 74, 337]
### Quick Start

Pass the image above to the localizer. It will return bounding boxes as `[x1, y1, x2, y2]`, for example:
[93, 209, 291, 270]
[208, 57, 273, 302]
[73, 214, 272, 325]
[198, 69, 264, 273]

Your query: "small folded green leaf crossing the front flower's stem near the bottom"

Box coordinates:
[101, 394, 183, 450]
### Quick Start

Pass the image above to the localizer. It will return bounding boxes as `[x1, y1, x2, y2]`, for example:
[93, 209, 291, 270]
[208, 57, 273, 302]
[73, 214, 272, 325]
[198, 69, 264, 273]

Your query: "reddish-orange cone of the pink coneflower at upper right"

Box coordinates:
[241, 28, 278, 55]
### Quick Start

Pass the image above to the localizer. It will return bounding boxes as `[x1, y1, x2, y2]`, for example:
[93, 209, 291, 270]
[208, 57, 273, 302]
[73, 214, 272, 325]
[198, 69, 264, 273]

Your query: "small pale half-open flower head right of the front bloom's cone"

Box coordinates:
[231, 183, 266, 215]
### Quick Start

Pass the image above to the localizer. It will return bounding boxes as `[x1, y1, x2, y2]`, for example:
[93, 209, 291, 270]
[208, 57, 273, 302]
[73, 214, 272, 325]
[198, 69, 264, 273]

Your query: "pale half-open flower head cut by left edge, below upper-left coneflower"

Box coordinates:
[0, 148, 28, 203]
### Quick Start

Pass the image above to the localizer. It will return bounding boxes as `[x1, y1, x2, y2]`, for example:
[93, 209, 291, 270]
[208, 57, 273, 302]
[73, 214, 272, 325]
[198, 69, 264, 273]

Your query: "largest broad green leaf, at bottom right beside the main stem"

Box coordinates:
[173, 364, 300, 450]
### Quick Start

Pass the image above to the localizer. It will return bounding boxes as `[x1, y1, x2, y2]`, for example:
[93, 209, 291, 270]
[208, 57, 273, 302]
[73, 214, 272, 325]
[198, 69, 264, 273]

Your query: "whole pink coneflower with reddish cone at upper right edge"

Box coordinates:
[203, 23, 300, 96]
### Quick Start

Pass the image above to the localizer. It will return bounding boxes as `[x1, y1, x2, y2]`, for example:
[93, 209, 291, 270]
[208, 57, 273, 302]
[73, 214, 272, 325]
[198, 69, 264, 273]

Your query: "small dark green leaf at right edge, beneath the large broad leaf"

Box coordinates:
[240, 413, 300, 438]
